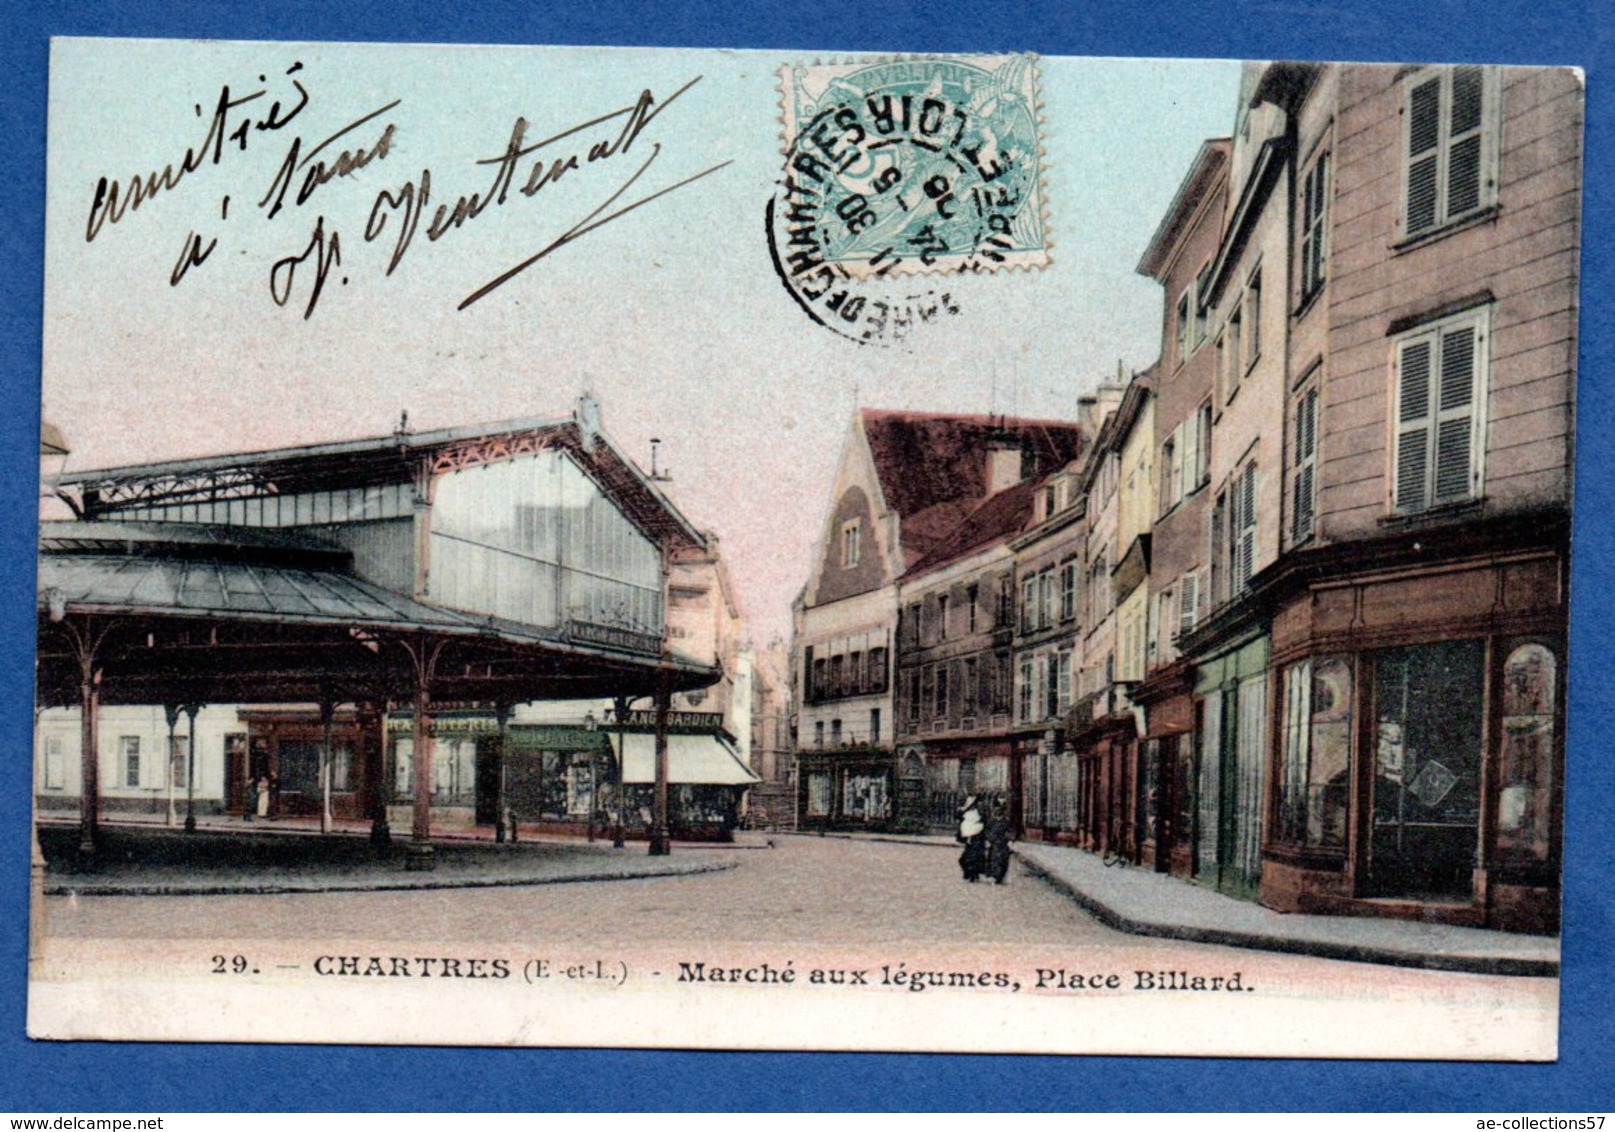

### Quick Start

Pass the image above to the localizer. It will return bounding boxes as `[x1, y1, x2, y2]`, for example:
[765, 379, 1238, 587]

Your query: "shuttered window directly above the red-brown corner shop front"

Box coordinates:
[1391, 310, 1489, 514]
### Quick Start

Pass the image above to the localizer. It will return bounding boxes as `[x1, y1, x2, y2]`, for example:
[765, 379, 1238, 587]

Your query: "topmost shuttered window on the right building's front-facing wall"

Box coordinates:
[1402, 66, 1497, 239]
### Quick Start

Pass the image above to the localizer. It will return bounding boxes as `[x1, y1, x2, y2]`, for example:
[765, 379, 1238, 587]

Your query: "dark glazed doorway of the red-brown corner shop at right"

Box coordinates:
[1368, 641, 1486, 901]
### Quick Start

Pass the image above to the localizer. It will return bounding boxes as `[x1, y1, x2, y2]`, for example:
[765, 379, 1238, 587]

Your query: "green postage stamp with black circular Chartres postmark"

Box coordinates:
[766, 55, 1048, 344]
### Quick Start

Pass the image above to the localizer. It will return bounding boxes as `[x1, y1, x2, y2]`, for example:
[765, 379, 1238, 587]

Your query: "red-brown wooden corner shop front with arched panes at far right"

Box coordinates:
[1261, 532, 1565, 932]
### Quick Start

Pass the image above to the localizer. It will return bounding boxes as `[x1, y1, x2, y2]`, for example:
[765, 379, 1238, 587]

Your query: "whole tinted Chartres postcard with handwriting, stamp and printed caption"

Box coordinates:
[31, 39, 1584, 1061]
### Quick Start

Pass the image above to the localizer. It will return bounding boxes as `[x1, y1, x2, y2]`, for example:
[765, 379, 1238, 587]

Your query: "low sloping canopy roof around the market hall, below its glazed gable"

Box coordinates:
[37, 522, 719, 704]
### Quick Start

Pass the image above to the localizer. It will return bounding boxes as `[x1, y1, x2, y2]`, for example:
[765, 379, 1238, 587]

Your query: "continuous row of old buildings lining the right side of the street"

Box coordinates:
[793, 63, 1583, 932]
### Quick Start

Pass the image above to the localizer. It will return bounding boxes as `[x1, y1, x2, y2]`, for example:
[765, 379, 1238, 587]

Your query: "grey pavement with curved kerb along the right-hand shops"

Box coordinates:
[1014, 841, 1558, 977]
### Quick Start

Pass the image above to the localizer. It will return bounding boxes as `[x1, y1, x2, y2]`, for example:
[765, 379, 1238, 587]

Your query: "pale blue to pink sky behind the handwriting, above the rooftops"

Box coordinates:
[44, 40, 1239, 636]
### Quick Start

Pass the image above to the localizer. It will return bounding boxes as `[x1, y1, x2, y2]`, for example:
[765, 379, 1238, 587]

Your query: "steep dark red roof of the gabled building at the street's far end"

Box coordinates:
[862, 409, 1087, 525]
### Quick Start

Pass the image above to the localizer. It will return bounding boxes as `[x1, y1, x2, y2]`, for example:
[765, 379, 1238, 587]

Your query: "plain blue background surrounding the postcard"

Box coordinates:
[0, 0, 1615, 1114]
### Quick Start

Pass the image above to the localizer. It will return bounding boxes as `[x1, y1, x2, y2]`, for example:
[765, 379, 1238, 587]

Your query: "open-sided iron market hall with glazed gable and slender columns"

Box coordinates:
[37, 397, 733, 867]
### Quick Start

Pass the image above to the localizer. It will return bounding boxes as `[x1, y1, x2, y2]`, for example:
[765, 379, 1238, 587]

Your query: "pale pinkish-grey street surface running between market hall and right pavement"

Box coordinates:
[47, 836, 1175, 951]
